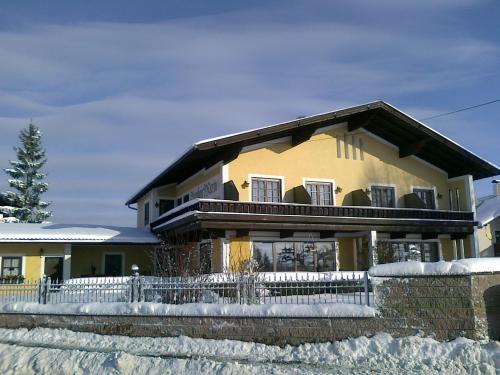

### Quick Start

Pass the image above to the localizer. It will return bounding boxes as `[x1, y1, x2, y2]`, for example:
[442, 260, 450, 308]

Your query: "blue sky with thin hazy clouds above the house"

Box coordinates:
[0, 0, 500, 225]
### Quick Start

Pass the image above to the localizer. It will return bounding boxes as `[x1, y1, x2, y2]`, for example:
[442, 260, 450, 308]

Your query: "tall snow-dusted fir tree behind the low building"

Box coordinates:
[0, 123, 52, 223]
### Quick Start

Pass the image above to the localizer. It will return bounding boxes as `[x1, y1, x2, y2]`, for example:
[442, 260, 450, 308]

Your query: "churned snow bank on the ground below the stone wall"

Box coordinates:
[0, 328, 500, 375]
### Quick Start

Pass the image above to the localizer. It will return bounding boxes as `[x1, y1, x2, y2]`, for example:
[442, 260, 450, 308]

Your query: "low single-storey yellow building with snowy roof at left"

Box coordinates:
[0, 223, 158, 280]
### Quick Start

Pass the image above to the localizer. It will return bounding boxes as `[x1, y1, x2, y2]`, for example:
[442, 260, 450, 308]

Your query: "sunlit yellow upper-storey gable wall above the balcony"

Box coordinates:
[228, 128, 448, 209]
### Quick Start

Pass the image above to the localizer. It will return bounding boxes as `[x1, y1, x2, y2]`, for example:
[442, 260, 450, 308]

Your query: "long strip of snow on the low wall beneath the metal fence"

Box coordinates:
[0, 302, 375, 318]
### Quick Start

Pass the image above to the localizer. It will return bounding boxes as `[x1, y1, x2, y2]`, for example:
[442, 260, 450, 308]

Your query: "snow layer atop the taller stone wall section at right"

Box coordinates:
[368, 258, 500, 276]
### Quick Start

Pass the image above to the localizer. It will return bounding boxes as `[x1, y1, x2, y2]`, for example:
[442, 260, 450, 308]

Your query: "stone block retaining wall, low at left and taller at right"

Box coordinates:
[0, 274, 500, 345]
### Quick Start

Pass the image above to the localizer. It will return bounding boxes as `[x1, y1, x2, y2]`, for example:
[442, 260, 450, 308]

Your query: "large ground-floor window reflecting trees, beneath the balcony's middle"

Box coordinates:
[253, 241, 337, 272]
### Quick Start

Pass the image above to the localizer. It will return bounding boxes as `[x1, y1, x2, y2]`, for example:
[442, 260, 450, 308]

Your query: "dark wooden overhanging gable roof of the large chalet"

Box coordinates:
[125, 101, 500, 205]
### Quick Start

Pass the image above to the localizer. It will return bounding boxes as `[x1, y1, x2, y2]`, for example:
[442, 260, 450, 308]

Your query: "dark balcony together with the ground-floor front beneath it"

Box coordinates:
[151, 199, 476, 272]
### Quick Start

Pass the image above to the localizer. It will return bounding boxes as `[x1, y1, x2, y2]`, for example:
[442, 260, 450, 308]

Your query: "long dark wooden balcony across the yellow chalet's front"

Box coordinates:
[151, 199, 475, 234]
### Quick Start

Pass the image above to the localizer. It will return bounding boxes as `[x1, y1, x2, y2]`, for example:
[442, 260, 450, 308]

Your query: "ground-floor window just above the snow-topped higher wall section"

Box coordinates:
[377, 241, 439, 263]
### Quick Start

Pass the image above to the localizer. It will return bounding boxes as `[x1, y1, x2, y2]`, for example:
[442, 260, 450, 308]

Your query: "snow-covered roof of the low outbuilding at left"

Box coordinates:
[0, 223, 159, 244]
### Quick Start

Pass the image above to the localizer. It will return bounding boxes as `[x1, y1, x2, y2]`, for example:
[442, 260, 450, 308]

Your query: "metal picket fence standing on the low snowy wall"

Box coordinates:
[0, 272, 373, 305]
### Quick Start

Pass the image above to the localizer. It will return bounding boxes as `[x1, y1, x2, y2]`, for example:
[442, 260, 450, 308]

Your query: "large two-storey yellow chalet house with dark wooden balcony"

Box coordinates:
[120, 101, 500, 272]
